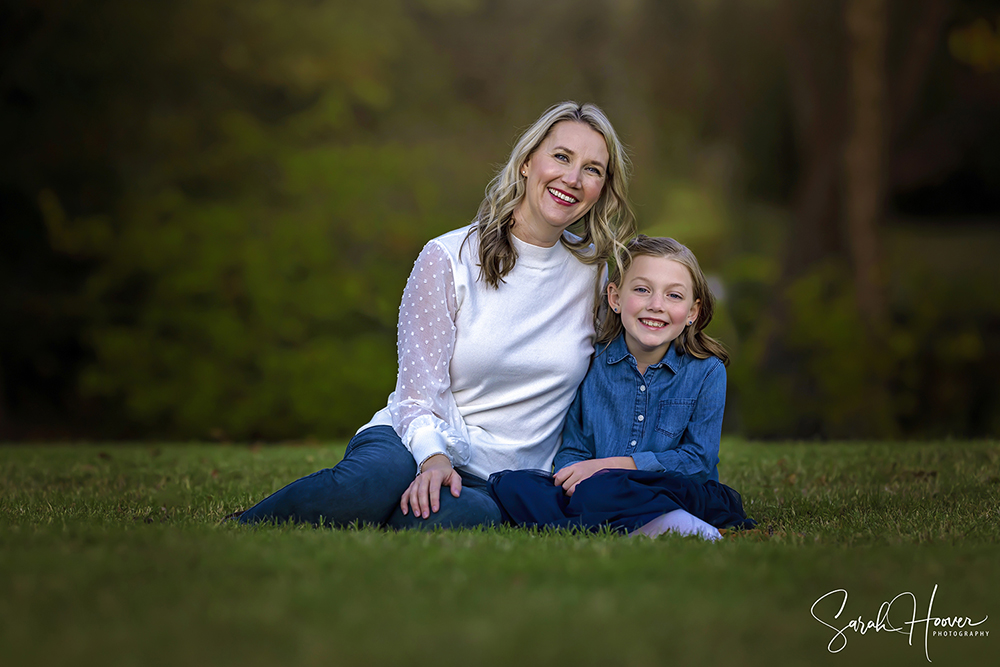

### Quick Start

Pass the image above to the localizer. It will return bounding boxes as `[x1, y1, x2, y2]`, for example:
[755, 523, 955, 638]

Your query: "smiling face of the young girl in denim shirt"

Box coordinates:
[608, 255, 701, 365]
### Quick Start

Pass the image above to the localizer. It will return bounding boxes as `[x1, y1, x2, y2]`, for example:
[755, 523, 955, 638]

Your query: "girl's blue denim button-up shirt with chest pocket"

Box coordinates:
[554, 334, 726, 482]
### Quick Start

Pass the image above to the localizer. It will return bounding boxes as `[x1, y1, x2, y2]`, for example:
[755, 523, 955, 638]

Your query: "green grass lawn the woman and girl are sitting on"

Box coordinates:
[0, 440, 1000, 667]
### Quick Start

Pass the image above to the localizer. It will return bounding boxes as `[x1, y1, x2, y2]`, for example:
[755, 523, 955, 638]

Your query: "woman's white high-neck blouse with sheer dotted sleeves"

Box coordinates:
[359, 227, 601, 479]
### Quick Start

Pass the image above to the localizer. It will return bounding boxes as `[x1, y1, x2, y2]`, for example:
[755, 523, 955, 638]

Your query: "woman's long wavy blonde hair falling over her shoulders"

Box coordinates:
[467, 102, 635, 288]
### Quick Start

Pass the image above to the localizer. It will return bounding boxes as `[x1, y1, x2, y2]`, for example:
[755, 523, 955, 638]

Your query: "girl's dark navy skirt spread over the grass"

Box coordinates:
[490, 470, 756, 532]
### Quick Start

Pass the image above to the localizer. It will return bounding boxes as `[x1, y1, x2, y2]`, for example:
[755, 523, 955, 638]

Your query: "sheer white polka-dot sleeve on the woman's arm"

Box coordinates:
[389, 241, 470, 466]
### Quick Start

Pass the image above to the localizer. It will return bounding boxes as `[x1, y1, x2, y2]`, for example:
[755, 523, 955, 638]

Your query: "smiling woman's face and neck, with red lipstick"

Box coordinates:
[513, 121, 608, 246]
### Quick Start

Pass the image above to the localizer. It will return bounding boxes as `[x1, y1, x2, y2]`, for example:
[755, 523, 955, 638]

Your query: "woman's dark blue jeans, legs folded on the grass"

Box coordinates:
[239, 426, 500, 530]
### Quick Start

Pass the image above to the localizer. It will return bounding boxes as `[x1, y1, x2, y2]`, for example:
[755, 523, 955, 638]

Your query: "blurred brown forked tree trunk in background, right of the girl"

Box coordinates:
[736, 0, 968, 436]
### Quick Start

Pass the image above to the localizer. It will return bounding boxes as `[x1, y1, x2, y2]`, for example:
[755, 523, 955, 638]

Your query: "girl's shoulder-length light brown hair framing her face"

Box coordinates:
[597, 234, 729, 366]
